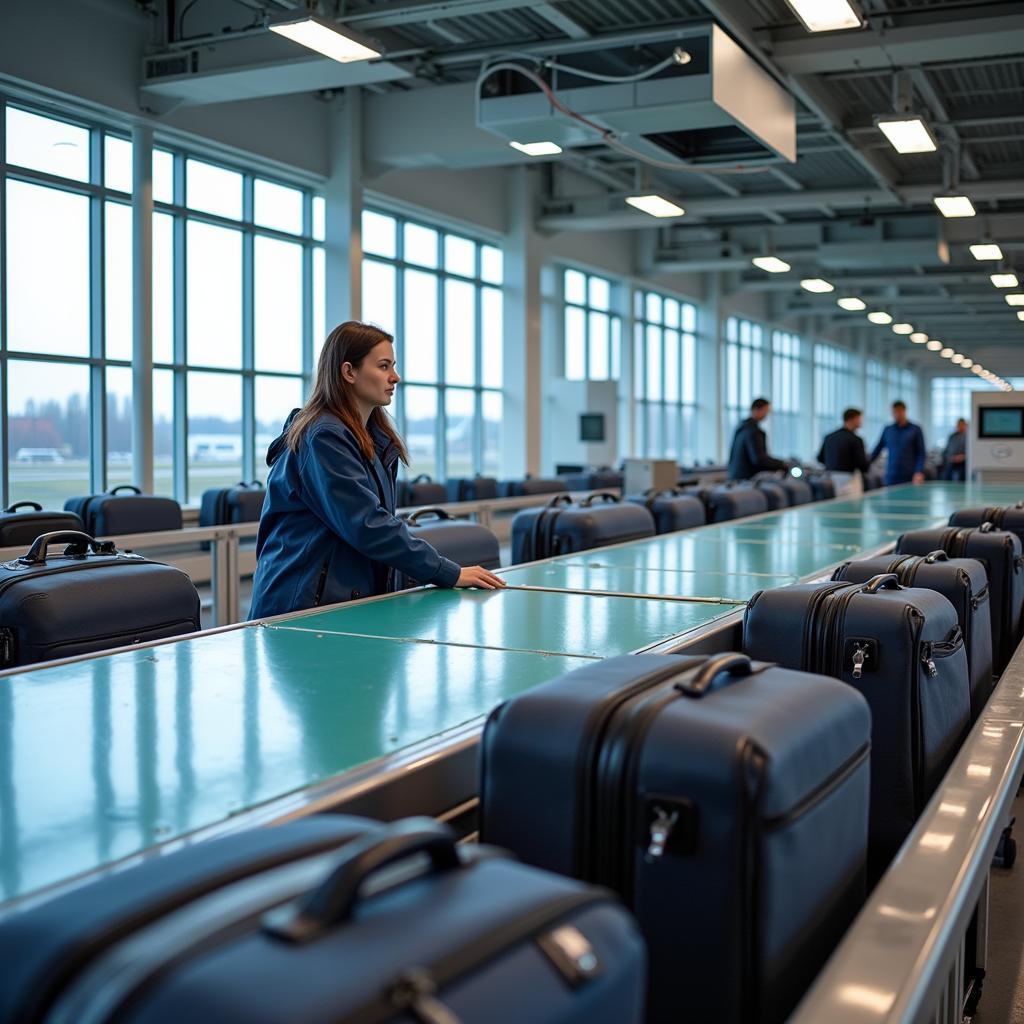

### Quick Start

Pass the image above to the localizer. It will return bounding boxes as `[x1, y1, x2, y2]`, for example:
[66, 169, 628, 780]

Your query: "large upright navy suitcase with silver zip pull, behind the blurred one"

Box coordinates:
[480, 654, 870, 1024]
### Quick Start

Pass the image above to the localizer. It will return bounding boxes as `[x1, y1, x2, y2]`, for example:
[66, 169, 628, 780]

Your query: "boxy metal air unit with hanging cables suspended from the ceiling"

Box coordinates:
[476, 25, 797, 166]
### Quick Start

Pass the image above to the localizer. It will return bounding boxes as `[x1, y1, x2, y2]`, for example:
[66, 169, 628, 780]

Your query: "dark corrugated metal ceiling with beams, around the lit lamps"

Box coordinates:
[148, 0, 1024, 376]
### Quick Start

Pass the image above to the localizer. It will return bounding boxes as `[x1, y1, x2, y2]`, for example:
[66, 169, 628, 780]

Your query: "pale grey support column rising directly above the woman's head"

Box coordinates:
[324, 86, 362, 331]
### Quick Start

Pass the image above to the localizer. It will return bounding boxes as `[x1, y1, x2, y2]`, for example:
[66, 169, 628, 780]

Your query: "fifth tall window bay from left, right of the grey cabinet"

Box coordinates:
[633, 292, 698, 465]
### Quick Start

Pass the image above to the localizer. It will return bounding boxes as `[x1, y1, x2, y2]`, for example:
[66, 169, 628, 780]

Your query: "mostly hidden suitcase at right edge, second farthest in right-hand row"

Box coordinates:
[896, 523, 1024, 676]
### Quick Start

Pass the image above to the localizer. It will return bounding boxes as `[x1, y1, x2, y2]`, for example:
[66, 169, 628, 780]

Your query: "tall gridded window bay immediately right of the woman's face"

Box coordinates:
[362, 210, 503, 479]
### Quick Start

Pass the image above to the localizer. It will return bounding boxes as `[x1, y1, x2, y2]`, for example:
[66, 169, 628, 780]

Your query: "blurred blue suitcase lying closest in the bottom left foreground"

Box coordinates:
[0, 814, 645, 1024]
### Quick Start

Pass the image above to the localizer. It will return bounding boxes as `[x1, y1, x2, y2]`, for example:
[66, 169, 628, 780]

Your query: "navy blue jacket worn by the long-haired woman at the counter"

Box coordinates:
[249, 415, 460, 618]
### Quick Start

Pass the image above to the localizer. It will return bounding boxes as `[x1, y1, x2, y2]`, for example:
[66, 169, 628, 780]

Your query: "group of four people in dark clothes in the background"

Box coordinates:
[729, 398, 967, 486]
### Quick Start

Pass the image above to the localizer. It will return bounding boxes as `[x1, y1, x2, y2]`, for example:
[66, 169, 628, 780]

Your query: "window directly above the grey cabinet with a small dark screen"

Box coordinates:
[562, 268, 623, 381]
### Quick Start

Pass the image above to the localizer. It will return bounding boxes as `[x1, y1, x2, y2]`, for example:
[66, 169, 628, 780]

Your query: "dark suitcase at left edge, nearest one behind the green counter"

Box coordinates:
[0, 530, 202, 667]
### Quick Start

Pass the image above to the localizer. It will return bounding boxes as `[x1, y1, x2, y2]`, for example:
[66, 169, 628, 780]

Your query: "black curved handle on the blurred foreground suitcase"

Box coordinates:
[263, 817, 462, 943]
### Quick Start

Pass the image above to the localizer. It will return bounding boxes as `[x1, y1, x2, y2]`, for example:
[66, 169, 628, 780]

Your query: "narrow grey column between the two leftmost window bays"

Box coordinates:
[131, 125, 154, 494]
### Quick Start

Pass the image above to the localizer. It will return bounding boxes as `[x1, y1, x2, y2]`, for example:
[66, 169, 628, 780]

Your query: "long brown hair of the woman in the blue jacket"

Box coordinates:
[288, 321, 409, 466]
